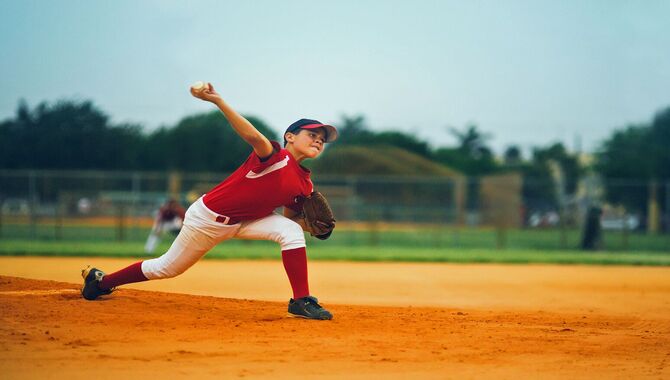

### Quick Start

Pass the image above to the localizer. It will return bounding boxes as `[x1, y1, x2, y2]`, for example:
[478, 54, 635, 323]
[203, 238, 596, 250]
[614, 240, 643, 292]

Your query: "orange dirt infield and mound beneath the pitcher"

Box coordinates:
[0, 257, 670, 379]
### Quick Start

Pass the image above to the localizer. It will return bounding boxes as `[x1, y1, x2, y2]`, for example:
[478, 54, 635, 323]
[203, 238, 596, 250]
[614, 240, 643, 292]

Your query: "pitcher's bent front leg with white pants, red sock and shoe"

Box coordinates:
[235, 214, 333, 319]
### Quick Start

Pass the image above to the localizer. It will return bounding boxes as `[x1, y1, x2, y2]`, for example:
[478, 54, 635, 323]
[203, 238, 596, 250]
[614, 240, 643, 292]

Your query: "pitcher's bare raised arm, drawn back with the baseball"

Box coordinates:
[191, 83, 274, 158]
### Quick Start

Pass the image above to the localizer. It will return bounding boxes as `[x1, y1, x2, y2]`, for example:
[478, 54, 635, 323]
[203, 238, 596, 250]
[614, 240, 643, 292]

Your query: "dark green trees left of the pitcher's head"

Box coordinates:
[0, 100, 276, 172]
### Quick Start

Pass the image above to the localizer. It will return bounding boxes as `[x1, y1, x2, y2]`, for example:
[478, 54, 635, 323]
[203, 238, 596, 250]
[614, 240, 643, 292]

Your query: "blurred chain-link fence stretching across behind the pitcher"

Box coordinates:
[0, 170, 670, 252]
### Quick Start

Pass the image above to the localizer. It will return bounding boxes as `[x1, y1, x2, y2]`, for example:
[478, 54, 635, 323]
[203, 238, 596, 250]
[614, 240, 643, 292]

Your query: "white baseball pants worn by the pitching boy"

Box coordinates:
[142, 197, 305, 280]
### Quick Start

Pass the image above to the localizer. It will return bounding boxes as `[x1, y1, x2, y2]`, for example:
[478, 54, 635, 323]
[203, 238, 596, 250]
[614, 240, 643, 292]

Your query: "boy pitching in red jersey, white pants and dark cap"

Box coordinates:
[81, 83, 338, 320]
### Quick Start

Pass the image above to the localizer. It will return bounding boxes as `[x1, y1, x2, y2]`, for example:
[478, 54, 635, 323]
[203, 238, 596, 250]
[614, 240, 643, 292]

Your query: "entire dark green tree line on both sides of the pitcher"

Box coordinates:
[0, 100, 670, 217]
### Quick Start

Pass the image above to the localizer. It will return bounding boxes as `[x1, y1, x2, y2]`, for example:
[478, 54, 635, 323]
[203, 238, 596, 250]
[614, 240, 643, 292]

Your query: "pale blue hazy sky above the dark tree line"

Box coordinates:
[0, 0, 670, 153]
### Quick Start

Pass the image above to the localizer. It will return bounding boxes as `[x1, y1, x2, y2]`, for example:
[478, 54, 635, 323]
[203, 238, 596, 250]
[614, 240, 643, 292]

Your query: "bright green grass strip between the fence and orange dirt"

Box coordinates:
[0, 239, 670, 266]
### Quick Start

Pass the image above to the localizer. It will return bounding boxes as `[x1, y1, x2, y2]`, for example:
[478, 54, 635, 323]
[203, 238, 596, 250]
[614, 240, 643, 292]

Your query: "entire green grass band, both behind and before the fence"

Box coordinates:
[0, 223, 670, 265]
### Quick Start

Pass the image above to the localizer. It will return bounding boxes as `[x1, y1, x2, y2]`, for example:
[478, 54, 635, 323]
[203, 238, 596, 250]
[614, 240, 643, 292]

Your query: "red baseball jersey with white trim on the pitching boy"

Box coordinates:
[203, 141, 314, 221]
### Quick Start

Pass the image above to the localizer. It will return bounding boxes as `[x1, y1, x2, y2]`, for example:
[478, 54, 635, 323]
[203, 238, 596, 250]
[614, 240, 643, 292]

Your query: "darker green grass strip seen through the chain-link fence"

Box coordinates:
[0, 224, 670, 253]
